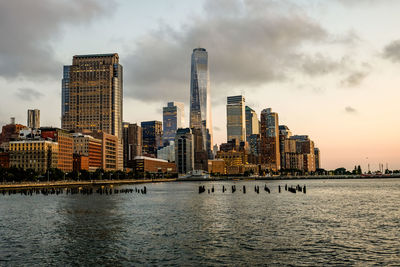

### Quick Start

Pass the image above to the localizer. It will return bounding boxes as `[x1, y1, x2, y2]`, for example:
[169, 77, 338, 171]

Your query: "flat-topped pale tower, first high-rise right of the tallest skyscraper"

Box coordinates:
[226, 95, 246, 142]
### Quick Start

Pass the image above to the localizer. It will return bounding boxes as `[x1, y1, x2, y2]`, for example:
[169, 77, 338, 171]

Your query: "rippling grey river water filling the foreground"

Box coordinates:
[0, 179, 400, 266]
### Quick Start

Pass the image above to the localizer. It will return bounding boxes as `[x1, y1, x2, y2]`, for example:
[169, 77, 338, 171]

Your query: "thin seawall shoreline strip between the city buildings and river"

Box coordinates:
[0, 175, 400, 190]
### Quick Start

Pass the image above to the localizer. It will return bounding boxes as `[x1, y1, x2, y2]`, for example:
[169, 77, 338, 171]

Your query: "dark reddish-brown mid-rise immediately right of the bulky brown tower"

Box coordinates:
[122, 122, 143, 168]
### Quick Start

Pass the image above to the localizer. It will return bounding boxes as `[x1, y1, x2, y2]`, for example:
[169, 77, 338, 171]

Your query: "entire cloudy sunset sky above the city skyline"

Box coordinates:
[0, 0, 400, 170]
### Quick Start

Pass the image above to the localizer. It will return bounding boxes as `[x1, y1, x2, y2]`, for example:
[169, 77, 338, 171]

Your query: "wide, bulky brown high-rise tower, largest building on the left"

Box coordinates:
[61, 53, 122, 139]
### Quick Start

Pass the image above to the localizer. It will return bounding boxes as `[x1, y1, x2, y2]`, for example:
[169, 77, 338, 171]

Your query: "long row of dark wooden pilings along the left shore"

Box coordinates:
[0, 186, 147, 196]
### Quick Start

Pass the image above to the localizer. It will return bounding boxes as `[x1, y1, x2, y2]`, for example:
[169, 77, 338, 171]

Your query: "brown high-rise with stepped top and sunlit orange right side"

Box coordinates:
[260, 108, 281, 171]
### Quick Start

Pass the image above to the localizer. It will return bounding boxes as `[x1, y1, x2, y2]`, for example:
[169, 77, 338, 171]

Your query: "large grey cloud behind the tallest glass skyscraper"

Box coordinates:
[123, 0, 336, 101]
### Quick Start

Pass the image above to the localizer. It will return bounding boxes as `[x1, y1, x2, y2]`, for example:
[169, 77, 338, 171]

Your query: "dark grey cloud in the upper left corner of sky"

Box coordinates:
[0, 0, 112, 79]
